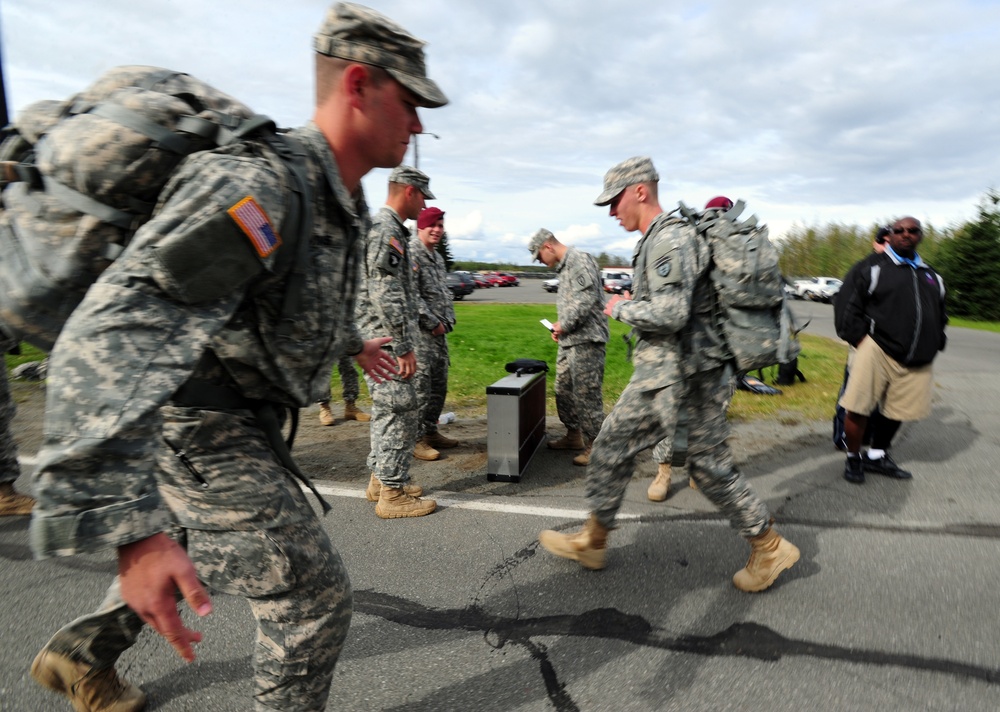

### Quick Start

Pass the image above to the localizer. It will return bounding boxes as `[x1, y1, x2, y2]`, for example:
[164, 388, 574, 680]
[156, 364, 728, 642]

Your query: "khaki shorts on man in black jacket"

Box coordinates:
[840, 337, 934, 420]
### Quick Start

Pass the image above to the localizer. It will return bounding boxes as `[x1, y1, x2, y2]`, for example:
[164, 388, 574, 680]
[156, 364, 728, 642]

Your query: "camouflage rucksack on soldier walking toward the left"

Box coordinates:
[680, 200, 801, 373]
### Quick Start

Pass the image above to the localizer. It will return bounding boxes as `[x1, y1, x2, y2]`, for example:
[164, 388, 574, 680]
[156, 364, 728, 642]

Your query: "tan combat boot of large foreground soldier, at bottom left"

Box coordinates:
[31, 648, 146, 712]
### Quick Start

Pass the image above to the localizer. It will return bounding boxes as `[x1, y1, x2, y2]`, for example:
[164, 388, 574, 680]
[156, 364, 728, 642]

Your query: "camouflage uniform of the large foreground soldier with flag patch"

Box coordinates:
[31, 123, 370, 710]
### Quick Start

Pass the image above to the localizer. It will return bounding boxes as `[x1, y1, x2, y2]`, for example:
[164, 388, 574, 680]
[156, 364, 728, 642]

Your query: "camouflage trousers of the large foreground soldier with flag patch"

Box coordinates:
[49, 407, 353, 712]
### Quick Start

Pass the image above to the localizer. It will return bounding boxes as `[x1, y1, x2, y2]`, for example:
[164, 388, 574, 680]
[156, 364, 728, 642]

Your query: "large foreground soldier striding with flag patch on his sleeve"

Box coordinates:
[31, 3, 447, 712]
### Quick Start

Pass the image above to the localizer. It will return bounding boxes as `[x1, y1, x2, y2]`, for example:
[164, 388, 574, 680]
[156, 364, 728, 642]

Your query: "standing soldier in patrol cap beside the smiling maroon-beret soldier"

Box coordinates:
[357, 166, 437, 519]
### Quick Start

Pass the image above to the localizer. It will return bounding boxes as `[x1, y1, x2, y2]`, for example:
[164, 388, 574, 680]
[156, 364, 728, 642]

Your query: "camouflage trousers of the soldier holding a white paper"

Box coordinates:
[555, 342, 606, 440]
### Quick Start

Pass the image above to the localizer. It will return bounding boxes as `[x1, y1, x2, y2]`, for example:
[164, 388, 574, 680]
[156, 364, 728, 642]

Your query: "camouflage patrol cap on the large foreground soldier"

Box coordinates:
[313, 2, 448, 109]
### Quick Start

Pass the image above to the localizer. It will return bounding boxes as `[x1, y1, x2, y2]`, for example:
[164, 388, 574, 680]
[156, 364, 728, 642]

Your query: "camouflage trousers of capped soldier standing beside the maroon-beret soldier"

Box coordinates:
[365, 376, 420, 488]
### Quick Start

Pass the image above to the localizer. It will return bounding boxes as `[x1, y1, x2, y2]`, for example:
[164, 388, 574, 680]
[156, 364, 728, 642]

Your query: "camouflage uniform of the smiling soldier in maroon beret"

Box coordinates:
[410, 237, 455, 439]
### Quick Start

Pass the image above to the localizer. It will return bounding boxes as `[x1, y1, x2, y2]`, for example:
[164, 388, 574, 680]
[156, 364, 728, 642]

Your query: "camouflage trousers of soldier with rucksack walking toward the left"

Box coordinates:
[587, 367, 770, 538]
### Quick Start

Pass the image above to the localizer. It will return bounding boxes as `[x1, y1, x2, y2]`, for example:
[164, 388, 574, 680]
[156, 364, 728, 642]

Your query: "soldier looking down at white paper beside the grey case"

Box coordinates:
[528, 229, 610, 465]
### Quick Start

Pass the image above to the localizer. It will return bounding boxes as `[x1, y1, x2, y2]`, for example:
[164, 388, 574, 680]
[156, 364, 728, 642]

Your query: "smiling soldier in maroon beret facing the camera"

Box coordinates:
[410, 208, 458, 460]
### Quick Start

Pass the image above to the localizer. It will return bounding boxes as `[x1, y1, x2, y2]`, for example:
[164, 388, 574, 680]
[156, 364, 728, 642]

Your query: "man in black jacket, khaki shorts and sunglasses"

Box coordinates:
[834, 217, 948, 484]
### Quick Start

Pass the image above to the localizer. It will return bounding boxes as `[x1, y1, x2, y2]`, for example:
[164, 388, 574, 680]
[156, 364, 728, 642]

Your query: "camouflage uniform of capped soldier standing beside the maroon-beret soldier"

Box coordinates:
[357, 205, 419, 488]
